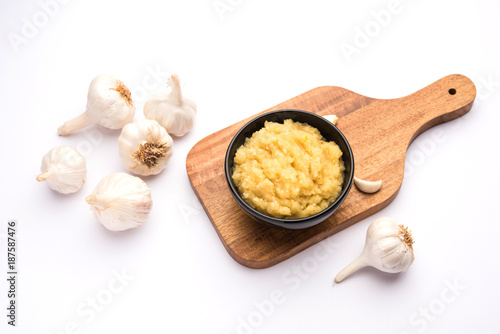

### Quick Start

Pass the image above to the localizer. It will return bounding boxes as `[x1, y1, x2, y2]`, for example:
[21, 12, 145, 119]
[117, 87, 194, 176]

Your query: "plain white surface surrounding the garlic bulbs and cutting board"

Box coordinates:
[0, 0, 500, 334]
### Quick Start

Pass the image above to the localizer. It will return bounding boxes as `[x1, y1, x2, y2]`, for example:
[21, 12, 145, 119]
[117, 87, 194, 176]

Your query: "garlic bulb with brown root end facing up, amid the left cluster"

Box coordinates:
[118, 119, 173, 175]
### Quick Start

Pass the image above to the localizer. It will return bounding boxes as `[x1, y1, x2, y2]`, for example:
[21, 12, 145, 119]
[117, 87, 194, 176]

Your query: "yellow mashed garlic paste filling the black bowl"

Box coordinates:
[232, 119, 345, 219]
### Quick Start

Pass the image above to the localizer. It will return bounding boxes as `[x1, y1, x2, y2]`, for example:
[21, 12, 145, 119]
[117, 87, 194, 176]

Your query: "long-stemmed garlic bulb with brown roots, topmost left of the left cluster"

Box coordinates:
[57, 75, 135, 136]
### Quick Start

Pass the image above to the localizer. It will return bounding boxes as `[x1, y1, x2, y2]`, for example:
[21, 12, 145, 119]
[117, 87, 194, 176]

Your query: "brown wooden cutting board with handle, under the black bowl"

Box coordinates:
[186, 75, 476, 268]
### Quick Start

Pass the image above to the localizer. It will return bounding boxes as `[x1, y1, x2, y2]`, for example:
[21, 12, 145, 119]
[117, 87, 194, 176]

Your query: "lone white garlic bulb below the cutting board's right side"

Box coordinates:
[335, 217, 415, 283]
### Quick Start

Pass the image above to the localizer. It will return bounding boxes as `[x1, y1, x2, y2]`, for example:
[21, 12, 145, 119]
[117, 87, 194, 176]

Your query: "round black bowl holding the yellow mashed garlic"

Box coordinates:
[224, 109, 354, 229]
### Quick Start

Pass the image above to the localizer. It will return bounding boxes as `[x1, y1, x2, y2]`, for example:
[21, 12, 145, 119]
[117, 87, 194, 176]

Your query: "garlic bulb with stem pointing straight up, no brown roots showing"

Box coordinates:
[144, 74, 196, 137]
